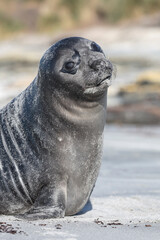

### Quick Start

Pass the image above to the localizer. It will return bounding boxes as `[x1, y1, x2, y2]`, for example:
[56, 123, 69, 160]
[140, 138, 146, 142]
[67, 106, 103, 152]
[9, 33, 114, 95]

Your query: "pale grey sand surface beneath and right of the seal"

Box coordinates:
[0, 125, 160, 240]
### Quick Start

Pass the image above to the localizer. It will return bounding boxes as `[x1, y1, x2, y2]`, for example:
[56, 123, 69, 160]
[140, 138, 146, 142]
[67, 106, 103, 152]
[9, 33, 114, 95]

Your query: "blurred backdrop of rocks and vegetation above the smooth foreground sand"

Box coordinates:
[0, 0, 160, 125]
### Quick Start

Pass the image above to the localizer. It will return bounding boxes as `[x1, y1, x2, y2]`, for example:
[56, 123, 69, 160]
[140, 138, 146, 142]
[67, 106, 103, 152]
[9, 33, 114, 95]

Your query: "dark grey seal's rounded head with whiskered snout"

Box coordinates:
[39, 37, 113, 99]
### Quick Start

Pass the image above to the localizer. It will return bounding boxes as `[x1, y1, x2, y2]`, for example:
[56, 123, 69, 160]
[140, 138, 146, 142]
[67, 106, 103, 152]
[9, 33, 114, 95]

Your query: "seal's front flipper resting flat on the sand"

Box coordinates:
[17, 181, 67, 220]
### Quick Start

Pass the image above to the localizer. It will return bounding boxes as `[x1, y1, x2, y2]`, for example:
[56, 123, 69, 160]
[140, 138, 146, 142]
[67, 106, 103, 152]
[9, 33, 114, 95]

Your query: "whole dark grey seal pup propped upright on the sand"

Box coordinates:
[0, 37, 112, 219]
